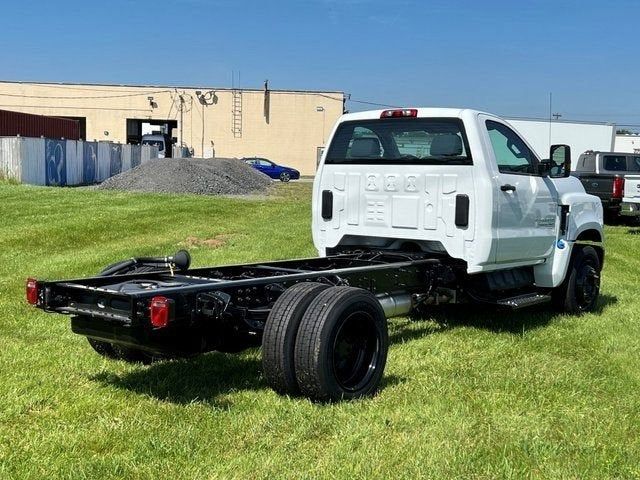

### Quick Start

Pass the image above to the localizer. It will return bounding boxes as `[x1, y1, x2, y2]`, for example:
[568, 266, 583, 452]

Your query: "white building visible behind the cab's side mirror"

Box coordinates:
[507, 118, 616, 162]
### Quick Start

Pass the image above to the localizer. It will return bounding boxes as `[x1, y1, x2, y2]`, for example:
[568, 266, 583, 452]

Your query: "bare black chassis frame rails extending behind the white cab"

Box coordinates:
[37, 251, 455, 356]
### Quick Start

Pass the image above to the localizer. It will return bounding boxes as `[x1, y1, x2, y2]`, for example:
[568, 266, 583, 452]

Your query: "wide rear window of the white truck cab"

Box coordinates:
[325, 118, 471, 165]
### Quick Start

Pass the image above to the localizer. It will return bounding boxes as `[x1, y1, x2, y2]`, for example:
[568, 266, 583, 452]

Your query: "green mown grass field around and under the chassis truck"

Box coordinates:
[0, 183, 640, 479]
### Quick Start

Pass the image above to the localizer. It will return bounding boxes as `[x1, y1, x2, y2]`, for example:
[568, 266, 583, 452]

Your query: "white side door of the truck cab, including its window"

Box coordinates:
[484, 118, 558, 263]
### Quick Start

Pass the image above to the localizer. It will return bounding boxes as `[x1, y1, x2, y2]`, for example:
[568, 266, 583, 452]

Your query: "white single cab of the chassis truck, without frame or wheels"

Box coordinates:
[312, 108, 603, 288]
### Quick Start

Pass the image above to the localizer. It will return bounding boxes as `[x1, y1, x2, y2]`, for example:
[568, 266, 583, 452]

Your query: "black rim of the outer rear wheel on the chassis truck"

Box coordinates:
[332, 312, 380, 391]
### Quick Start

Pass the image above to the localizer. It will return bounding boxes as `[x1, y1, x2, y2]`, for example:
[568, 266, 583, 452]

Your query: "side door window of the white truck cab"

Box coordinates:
[486, 120, 537, 175]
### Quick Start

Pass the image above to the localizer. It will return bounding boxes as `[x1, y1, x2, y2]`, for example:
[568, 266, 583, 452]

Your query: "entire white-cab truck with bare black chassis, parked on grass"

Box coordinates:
[26, 108, 604, 401]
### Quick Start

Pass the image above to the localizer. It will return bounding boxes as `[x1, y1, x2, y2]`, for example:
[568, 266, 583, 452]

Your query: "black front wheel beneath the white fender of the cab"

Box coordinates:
[552, 246, 601, 314]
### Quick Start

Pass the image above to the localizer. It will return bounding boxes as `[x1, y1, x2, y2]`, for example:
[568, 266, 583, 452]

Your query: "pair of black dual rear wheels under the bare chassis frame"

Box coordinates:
[262, 282, 389, 401]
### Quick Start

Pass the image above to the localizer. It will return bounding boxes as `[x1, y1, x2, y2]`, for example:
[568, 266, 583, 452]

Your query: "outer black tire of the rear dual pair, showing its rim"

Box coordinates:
[294, 287, 389, 402]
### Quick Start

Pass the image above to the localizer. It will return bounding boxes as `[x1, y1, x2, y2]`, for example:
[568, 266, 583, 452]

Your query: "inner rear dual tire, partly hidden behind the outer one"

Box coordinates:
[262, 282, 329, 395]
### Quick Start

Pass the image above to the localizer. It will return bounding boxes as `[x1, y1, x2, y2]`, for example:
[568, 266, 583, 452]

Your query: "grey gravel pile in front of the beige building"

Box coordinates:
[98, 158, 271, 195]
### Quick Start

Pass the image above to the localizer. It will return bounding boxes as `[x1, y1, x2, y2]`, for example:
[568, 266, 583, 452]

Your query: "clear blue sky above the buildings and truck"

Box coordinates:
[0, 0, 640, 125]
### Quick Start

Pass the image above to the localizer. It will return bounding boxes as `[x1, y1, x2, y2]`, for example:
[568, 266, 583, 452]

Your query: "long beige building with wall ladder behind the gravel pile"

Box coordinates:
[0, 82, 345, 175]
